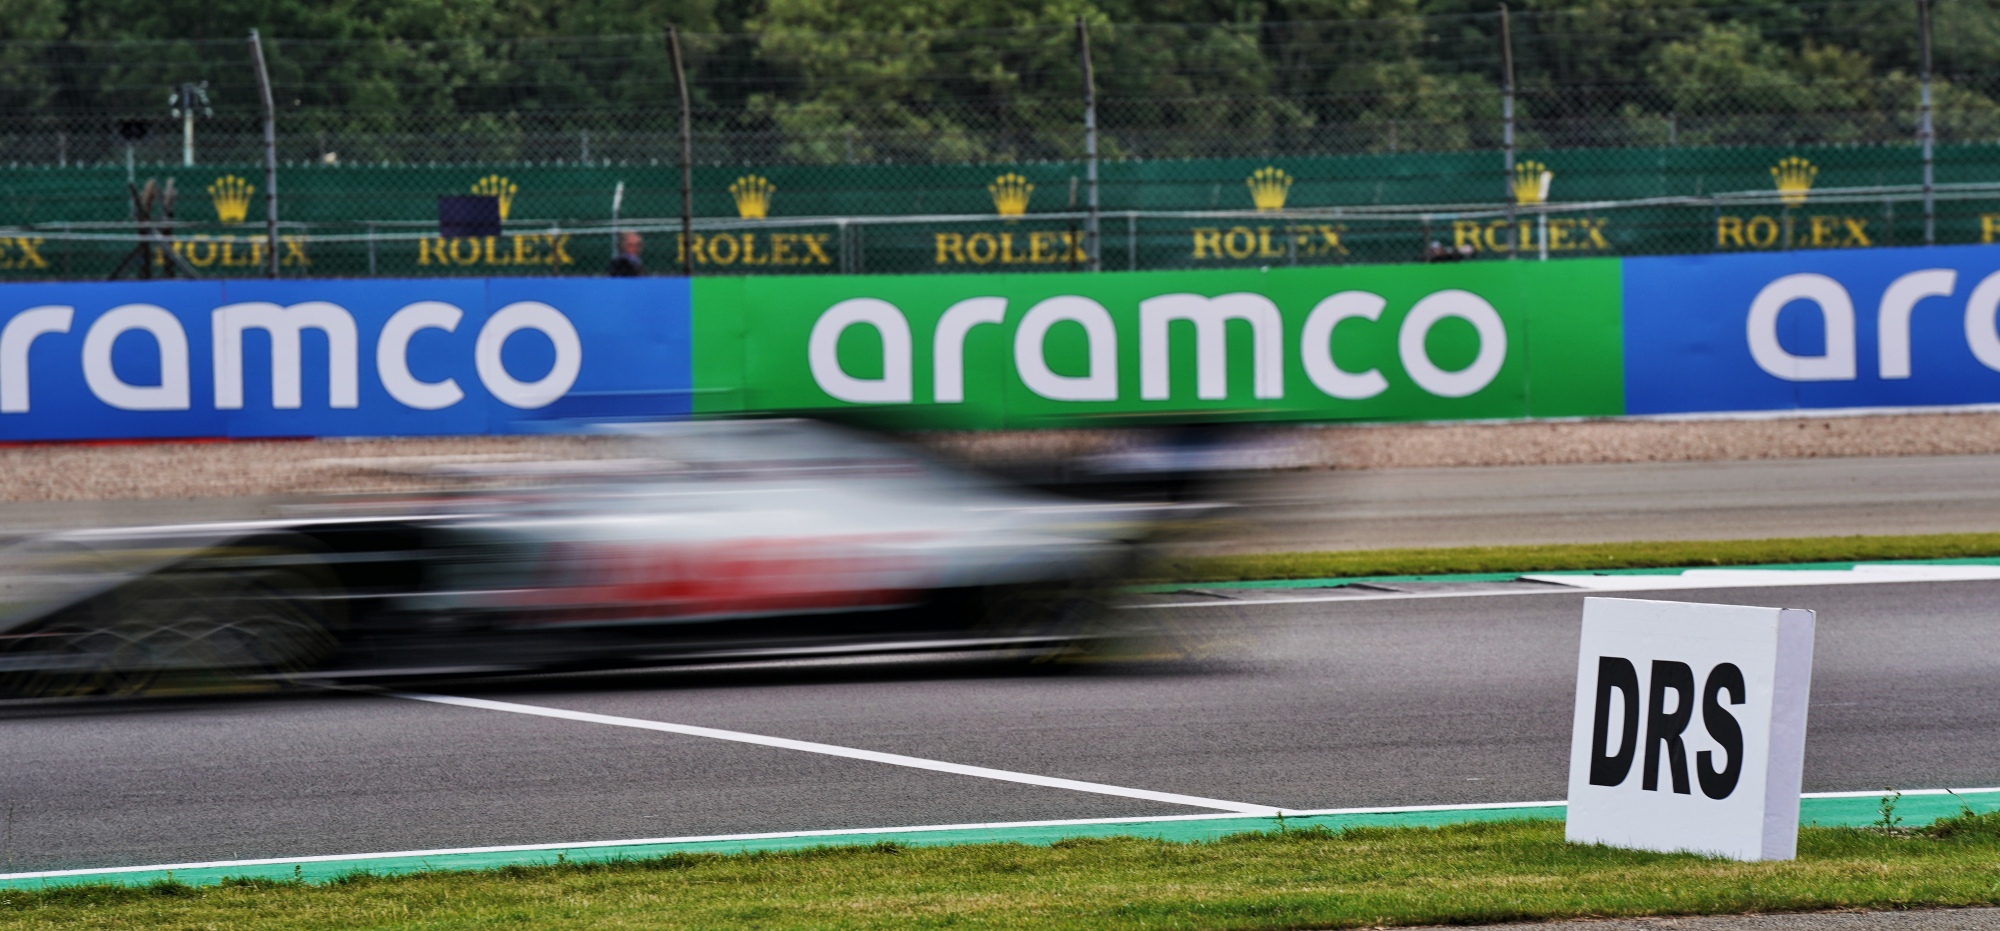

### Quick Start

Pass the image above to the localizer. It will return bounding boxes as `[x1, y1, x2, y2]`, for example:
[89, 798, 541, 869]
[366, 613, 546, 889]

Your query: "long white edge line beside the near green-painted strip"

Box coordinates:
[0, 787, 2000, 881]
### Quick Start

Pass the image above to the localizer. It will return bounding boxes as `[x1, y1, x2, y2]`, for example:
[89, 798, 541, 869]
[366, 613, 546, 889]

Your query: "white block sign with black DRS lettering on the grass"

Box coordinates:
[1568, 597, 1814, 859]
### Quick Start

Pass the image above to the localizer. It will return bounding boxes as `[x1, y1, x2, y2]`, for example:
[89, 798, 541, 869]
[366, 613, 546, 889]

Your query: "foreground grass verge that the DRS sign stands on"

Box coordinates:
[11, 813, 2000, 931]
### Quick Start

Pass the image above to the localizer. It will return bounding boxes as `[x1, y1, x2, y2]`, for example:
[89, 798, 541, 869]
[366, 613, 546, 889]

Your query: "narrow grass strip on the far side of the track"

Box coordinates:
[1152, 533, 2000, 581]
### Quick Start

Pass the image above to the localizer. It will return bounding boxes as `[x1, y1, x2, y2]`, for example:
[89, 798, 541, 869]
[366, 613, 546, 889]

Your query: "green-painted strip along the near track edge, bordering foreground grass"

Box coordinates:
[0, 789, 2000, 889]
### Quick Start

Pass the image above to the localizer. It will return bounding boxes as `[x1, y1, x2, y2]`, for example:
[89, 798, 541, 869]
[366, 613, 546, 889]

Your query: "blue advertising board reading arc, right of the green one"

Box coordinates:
[1624, 246, 2000, 414]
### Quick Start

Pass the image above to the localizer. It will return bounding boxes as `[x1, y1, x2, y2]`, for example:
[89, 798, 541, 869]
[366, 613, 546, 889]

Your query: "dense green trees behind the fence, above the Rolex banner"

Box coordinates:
[0, 0, 2000, 164]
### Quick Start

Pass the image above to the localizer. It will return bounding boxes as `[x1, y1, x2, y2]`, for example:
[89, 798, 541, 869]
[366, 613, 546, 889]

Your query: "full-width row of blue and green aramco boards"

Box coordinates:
[15, 246, 2000, 442]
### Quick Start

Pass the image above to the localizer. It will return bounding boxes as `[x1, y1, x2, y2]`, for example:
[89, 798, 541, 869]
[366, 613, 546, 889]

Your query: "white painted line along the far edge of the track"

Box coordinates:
[1122, 563, 2000, 611]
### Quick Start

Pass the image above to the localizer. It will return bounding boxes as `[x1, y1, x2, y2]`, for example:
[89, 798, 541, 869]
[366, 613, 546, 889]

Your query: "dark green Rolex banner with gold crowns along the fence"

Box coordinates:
[11, 144, 2000, 280]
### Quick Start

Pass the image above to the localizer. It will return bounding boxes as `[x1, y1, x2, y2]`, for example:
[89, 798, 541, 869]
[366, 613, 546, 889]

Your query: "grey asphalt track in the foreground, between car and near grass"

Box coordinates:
[0, 581, 2000, 871]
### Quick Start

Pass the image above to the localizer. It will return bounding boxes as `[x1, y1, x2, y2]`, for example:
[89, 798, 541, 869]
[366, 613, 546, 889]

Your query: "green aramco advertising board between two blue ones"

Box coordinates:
[694, 260, 1624, 430]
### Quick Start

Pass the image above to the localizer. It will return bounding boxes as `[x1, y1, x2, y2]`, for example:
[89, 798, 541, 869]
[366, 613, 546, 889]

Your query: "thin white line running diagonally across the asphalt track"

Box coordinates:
[380, 691, 1290, 815]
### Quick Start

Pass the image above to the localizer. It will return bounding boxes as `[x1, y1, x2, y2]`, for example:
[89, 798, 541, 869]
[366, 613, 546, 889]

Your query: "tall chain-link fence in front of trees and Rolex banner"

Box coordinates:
[0, 0, 2000, 278]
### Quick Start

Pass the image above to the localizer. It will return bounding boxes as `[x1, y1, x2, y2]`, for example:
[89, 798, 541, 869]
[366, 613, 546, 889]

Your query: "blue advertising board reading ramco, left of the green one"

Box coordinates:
[0, 278, 692, 442]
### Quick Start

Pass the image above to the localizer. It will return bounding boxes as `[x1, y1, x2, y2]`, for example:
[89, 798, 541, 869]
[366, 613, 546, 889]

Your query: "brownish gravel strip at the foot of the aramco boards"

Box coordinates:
[0, 412, 2000, 501]
